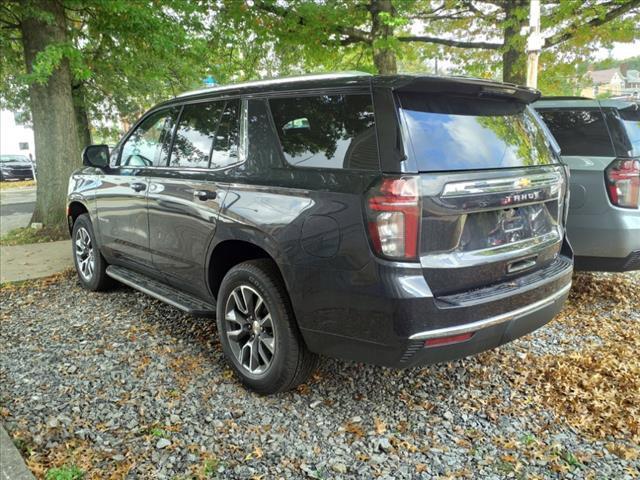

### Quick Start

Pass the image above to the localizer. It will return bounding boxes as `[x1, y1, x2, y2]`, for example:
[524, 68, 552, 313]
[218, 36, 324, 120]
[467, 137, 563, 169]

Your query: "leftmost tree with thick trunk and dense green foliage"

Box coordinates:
[0, 0, 232, 224]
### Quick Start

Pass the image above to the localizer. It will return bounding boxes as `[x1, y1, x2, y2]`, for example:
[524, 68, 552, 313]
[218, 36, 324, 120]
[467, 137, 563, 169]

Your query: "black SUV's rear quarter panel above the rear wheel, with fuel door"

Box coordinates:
[213, 168, 377, 336]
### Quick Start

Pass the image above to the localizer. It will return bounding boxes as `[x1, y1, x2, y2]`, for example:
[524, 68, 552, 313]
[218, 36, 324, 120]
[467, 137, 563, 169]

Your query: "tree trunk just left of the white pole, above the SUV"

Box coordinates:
[502, 0, 529, 85]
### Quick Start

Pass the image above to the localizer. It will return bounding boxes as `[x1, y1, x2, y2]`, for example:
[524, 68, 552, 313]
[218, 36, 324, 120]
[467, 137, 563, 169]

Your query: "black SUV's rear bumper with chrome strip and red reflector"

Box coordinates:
[292, 251, 573, 368]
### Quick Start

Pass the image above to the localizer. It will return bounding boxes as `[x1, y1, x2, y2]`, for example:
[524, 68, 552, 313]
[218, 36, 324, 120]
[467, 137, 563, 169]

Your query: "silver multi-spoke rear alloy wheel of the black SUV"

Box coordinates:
[224, 285, 276, 375]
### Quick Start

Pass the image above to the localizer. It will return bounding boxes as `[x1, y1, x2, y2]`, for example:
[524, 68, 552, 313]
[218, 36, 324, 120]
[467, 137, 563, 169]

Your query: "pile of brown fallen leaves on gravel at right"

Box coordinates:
[520, 275, 640, 444]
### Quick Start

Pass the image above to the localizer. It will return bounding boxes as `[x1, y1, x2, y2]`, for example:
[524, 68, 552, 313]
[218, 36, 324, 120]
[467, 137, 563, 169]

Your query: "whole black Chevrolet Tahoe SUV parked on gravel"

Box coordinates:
[68, 74, 573, 393]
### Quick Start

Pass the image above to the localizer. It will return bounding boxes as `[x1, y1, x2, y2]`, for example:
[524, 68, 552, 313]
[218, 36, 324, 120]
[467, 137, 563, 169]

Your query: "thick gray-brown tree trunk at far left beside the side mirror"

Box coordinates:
[21, 0, 81, 227]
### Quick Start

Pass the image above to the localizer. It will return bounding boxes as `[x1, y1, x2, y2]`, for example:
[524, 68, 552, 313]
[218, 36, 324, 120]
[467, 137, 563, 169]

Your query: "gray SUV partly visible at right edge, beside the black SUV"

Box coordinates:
[534, 98, 640, 271]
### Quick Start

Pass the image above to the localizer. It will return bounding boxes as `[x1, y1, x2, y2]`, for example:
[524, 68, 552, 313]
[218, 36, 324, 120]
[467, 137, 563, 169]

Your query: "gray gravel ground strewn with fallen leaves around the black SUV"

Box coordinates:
[0, 274, 640, 479]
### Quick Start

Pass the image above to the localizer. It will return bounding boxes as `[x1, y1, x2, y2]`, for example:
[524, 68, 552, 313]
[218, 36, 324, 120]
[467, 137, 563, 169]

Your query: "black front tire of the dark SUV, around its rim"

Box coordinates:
[71, 213, 113, 292]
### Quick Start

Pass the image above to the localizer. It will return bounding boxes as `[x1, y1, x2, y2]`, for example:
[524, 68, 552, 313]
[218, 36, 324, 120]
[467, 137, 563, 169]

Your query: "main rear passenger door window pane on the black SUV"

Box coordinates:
[170, 102, 224, 168]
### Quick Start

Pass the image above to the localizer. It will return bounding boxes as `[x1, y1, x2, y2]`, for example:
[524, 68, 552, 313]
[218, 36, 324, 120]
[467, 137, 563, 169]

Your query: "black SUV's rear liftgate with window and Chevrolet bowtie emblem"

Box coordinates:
[397, 92, 570, 296]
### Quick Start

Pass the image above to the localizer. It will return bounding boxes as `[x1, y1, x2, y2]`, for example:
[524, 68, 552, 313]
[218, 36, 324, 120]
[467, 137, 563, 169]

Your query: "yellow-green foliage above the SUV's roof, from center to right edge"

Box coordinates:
[226, 0, 640, 90]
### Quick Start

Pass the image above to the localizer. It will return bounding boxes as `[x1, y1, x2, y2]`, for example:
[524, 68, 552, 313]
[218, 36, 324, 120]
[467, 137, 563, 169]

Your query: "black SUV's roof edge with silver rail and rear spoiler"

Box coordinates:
[163, 71, 540, 104]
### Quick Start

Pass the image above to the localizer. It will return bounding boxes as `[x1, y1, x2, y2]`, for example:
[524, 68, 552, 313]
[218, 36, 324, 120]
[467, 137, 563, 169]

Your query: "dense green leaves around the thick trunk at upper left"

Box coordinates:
[0, 0, 220, 142]
